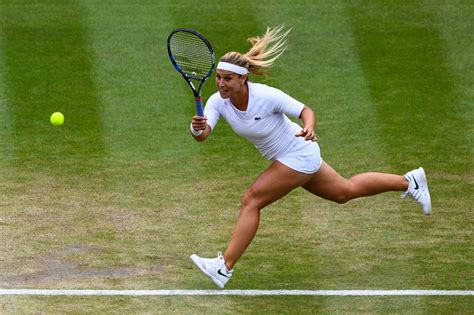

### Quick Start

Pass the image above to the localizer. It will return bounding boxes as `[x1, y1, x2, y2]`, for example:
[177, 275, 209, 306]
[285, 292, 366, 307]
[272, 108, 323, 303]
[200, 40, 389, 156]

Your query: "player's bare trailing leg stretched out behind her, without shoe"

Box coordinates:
[303, 162, 408, 203]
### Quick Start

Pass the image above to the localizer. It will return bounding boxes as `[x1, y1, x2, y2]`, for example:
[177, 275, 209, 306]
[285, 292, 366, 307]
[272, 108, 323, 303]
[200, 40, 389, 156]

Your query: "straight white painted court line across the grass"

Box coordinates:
[0, 289, 474, 296]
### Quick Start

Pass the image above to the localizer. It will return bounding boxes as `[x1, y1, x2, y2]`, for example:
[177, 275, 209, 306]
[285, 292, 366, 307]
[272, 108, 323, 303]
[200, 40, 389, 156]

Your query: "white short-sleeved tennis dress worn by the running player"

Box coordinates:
[204, 81, 322, 174]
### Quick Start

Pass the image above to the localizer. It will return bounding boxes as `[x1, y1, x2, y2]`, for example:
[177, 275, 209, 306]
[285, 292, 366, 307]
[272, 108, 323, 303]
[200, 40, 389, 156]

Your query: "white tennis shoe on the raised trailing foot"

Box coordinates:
[402, 167, 431, 215]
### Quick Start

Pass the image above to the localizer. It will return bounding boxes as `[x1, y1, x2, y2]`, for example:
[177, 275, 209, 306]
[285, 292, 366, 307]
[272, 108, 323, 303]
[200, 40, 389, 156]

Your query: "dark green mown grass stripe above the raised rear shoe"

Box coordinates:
[348, 1, 469, 173]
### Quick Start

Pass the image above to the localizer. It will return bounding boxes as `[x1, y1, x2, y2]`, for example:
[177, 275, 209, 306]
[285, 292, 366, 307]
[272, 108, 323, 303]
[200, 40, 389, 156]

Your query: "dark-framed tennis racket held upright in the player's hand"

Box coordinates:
[168, 28, 216, 117]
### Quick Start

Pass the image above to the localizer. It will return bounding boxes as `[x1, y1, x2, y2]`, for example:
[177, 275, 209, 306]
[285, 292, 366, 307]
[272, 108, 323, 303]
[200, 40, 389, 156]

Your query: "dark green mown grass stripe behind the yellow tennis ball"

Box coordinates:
[0, 2, 105, 174]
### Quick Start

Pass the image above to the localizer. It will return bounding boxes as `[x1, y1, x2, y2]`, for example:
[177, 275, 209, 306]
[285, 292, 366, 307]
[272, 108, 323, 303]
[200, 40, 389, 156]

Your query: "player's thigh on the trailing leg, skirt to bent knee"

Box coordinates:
[303, 162, 350, 200]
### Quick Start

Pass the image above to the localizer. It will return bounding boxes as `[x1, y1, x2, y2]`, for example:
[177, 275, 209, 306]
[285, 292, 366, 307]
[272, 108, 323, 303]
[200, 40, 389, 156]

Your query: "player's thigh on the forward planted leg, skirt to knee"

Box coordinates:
[243, 161, 313, 209]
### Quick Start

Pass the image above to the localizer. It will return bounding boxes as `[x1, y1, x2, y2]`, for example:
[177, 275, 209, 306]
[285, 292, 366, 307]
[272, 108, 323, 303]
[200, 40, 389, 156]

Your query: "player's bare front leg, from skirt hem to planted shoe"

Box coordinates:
[224, 161, 312, 270]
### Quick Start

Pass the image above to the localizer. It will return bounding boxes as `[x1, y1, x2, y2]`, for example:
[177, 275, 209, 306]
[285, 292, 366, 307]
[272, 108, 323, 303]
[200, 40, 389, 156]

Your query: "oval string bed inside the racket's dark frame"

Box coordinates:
[170, 32, 213, 78]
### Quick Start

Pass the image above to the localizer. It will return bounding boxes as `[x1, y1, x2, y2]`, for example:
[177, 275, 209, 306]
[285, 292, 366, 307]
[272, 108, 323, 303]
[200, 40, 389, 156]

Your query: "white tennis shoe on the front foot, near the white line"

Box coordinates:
[191, 252, 234, 289]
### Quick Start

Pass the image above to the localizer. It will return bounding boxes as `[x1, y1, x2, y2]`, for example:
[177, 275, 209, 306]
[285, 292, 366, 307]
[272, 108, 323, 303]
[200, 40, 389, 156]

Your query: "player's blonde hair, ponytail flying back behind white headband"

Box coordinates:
[220, 26, 291, 75]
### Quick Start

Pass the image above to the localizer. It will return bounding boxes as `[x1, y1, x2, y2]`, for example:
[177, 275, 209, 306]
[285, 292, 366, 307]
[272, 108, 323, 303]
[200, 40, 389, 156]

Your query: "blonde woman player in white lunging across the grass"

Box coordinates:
[190, 27, 431, 288]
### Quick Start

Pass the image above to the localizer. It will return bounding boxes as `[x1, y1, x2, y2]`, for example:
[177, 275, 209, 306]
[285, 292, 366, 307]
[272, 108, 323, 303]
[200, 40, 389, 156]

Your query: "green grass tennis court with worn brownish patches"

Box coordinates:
[0, 0, 474, 314]
